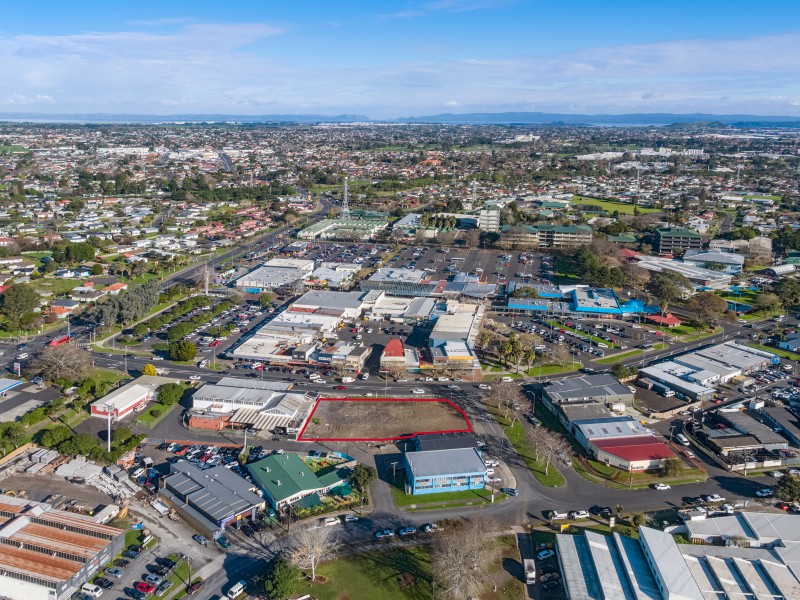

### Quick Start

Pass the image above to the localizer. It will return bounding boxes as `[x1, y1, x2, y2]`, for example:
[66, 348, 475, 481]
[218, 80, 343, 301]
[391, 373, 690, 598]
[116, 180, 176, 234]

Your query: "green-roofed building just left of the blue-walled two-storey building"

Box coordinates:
[247, 453, 350, 508]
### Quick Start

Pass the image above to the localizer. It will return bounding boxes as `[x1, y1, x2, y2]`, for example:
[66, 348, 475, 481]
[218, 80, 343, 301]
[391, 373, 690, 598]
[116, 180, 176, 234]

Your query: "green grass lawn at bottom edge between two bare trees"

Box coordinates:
[297, 546, 431, 600]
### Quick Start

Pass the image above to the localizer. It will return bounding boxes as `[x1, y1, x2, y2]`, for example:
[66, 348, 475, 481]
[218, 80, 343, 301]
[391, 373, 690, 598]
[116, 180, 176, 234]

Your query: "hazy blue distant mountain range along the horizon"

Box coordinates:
[0, 112, 800, 127]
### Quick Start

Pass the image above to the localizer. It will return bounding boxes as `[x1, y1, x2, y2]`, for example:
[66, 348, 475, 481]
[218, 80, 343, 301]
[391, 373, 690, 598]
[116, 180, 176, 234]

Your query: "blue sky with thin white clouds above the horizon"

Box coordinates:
[0, 0, 800, 119]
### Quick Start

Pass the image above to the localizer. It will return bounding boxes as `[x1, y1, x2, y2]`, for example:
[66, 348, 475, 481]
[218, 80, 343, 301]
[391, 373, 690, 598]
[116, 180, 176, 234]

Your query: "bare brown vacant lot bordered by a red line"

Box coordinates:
[297, 398, 472, 442]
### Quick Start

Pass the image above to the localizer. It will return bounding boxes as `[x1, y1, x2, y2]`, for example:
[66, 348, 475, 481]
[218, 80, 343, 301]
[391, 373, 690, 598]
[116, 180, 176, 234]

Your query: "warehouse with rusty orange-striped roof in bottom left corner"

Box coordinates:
[0, 496, 125, 600]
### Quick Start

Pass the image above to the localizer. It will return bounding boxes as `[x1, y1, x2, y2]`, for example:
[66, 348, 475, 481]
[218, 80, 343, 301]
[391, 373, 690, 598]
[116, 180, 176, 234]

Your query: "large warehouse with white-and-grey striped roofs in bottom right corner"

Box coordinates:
[556, 524, 800, 600]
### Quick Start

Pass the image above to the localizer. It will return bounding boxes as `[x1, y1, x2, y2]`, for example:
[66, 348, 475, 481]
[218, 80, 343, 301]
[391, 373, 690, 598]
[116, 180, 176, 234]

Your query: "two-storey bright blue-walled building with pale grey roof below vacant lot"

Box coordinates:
[403, 448, 486, 495]
